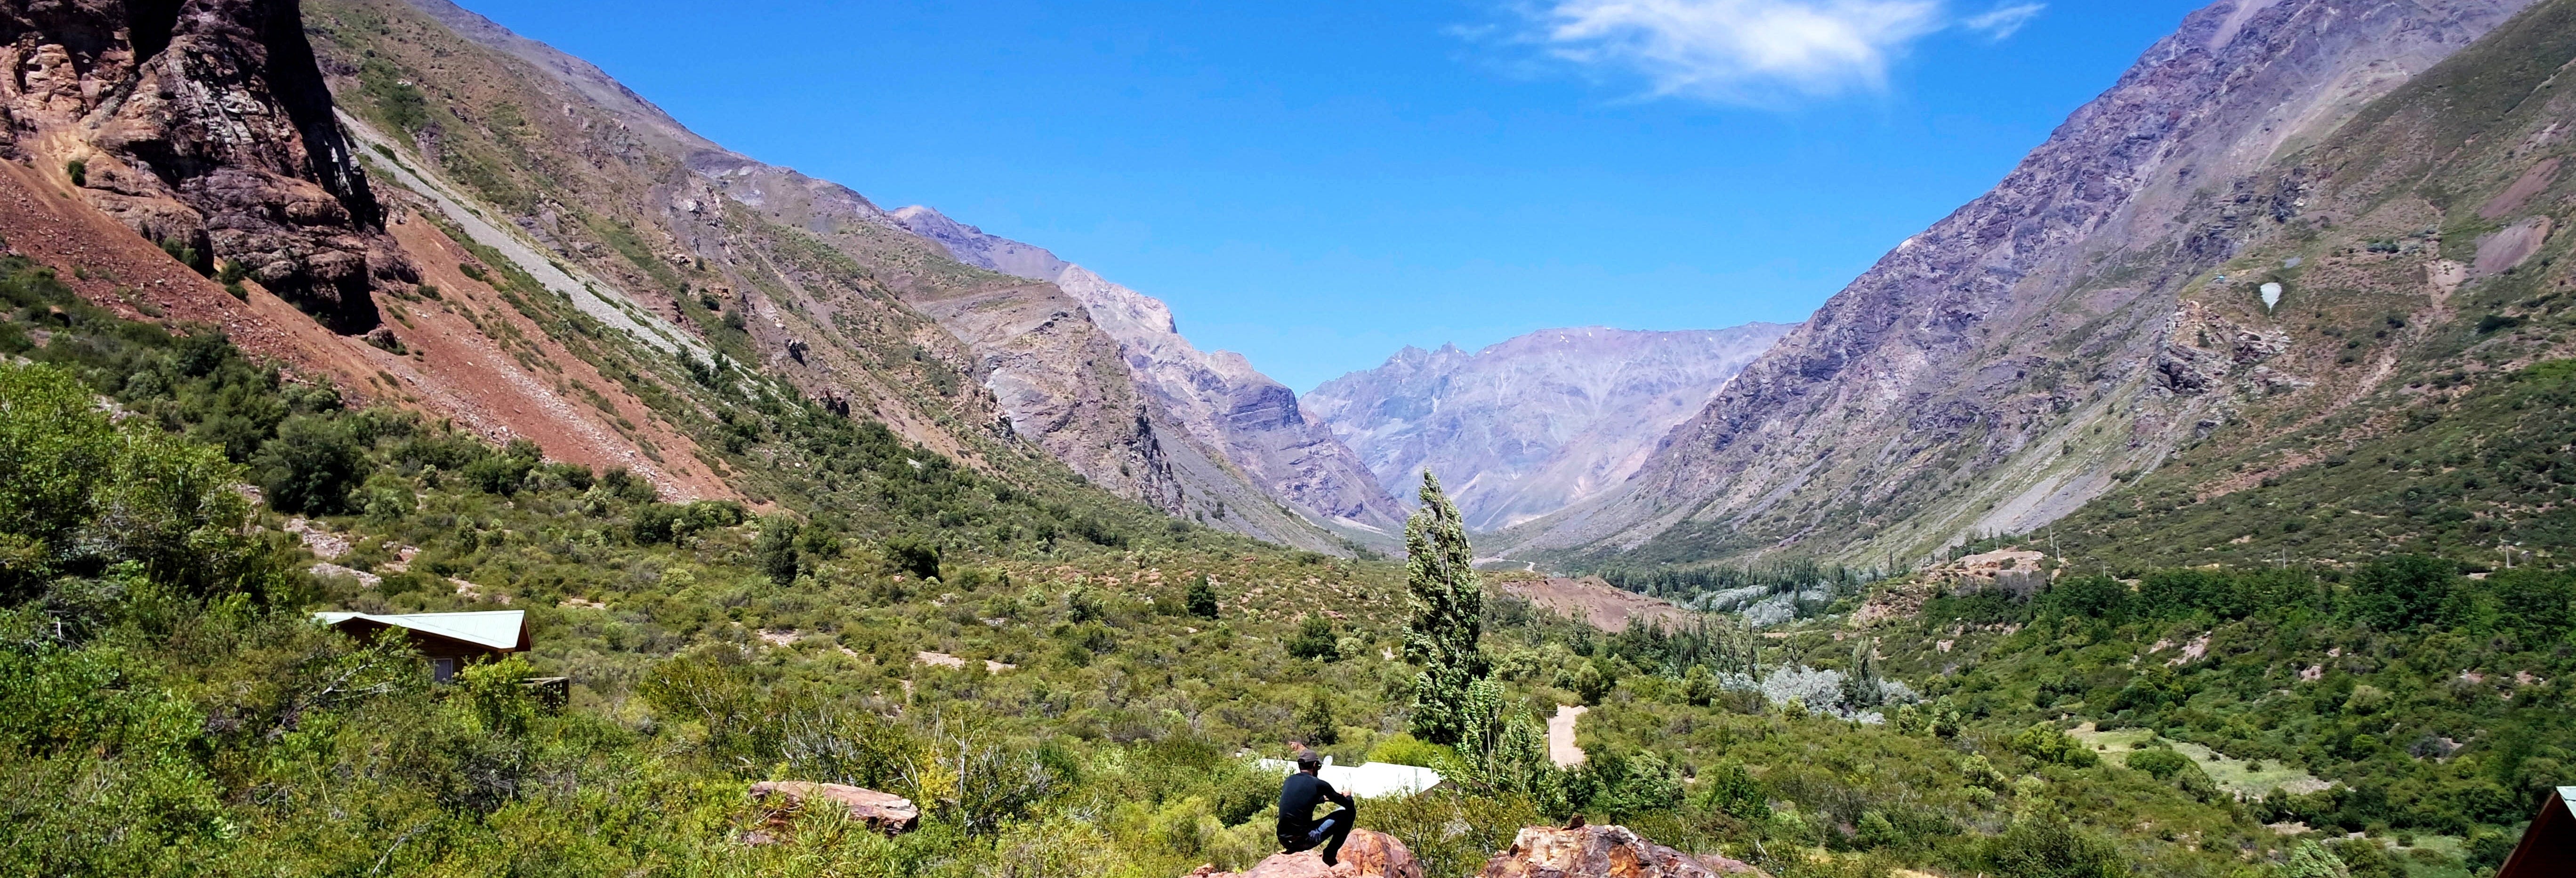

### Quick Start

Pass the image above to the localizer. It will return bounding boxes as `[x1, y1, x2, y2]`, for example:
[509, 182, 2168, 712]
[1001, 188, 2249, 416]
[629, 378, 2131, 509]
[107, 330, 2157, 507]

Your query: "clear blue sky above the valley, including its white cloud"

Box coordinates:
[466, 0, 2200, 391]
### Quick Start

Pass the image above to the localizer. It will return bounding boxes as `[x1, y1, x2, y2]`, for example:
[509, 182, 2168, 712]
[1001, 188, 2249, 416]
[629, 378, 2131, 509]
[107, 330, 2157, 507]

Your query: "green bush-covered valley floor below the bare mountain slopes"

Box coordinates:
[15, 246, 2563, 876]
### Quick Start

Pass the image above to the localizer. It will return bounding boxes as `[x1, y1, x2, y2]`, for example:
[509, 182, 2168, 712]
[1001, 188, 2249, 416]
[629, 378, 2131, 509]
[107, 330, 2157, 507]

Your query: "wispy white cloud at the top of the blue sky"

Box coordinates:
[1522, 0, 2040, 103]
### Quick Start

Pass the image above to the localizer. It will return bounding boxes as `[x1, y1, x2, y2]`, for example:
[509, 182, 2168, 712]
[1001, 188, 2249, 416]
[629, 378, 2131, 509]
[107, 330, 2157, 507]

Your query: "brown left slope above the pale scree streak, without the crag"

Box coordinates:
[330, 0, 1380, 551]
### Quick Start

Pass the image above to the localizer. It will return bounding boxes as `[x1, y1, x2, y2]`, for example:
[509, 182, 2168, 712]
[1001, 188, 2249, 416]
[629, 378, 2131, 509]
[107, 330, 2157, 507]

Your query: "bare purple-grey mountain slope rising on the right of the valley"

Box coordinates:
[1510, 0, 2525, 564]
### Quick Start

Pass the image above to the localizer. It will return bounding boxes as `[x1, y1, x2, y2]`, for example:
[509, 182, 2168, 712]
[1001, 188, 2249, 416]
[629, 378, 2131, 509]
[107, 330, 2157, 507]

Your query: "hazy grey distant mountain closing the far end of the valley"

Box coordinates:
[1306, 322, 1790, 531]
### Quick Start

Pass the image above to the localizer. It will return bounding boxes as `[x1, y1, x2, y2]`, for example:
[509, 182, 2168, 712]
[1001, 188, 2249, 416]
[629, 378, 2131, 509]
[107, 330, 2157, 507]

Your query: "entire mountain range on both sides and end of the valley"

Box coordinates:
[0, 0, 2558, 566]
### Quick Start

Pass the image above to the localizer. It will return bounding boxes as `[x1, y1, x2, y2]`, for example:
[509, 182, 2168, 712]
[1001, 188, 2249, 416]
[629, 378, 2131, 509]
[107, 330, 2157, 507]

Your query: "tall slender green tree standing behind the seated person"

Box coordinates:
[1404, 468, 1486, 744]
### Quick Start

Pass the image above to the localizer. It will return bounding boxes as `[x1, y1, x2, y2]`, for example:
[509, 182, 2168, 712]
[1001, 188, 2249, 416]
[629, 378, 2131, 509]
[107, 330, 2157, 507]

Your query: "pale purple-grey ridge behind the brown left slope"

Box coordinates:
[894, 206, 1404, 543]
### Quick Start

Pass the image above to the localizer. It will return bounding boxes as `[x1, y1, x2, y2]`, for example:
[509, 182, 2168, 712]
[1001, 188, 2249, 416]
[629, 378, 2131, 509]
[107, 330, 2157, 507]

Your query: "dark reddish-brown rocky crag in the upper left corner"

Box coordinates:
[0, 0, 417, 332]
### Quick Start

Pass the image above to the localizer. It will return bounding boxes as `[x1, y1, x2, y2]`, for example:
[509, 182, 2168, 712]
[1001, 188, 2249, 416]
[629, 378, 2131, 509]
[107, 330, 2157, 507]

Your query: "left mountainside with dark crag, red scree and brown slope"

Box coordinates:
[0, 0, 1391, 551]
